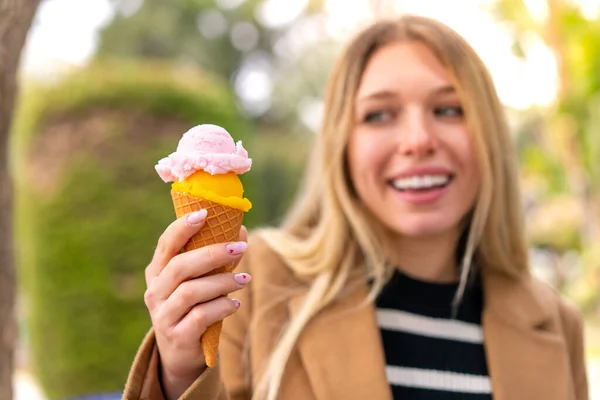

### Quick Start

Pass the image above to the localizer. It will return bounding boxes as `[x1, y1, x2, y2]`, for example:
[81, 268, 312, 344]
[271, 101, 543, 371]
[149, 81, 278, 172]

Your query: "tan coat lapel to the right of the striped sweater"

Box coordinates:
[482, 272, 575, 400]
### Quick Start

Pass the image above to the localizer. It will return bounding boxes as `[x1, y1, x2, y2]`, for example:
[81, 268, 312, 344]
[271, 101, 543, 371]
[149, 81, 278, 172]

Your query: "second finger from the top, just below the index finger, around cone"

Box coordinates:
[148, 242, 248, 301]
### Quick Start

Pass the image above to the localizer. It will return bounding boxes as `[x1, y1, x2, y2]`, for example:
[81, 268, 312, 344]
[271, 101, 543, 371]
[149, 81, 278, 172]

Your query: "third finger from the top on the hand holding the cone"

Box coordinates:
[157, 273, 251, 327]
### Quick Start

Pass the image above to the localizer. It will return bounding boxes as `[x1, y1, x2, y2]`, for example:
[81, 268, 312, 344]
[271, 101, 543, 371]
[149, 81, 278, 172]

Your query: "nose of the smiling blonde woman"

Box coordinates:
[398, 109, 438, 157]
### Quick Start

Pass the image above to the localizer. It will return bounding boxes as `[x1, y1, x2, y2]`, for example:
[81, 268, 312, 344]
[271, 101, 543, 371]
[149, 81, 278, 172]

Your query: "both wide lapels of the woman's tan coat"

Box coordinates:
[289, 272, 574, 400]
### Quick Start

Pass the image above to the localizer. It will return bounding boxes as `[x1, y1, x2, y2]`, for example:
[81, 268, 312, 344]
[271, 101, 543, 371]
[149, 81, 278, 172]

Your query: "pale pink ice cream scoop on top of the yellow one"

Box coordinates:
[154, 124, 252, 182]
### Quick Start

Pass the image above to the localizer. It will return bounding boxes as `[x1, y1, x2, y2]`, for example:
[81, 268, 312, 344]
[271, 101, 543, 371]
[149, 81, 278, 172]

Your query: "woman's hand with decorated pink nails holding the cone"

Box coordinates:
[144, 210, 250, 400]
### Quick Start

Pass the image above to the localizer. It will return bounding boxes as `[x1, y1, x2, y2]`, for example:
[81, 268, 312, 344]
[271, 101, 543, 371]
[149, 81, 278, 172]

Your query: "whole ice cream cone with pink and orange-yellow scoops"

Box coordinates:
[154, 124, 252, 367]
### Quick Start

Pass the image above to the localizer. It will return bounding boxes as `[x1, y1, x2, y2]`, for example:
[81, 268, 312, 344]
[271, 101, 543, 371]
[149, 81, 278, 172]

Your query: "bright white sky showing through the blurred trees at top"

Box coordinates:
[22, 0, 568, 108]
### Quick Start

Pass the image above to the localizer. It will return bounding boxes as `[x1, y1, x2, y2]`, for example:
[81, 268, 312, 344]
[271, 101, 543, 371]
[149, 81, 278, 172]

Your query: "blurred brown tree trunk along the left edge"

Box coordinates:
[0, 0, 39, 400]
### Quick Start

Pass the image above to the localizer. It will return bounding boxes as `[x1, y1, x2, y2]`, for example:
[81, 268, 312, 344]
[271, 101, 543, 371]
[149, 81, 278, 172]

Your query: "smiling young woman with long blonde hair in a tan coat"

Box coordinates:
[124, 16, 587, 400]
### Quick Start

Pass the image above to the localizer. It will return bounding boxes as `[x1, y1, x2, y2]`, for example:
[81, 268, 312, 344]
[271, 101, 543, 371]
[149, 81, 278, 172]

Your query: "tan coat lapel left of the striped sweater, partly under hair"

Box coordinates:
[289, 287, 392, 400]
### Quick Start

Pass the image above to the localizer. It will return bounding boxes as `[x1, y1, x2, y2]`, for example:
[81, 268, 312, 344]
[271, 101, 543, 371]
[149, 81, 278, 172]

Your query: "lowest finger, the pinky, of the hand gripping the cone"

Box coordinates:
[173, 297, 241, 342]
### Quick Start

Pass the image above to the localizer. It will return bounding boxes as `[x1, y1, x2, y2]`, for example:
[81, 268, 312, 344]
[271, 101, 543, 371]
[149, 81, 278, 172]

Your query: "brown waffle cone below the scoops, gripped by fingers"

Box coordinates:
[171, 191, 244, 367]
